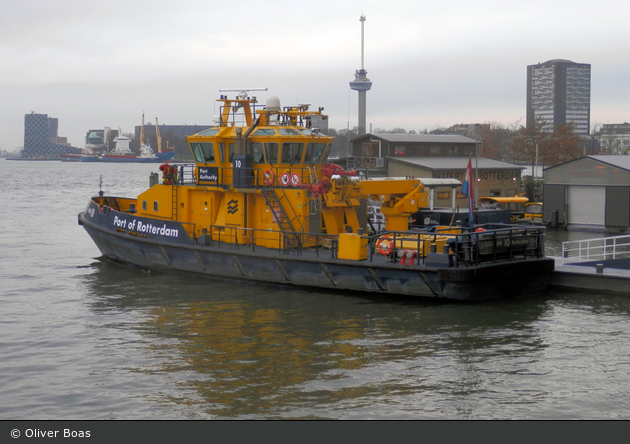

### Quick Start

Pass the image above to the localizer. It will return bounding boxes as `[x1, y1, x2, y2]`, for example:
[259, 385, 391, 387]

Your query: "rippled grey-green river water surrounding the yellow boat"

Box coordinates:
[0, 160, 630, 420]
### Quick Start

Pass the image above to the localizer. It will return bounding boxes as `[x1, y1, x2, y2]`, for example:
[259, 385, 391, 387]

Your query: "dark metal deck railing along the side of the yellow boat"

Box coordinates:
[196, 224, 545, 267]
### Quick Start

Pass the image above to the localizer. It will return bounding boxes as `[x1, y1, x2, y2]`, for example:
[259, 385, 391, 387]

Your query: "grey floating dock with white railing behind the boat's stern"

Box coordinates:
[549, 236, 630, 296]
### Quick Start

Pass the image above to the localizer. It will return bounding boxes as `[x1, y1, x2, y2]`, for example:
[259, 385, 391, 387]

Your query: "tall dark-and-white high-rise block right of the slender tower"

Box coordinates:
[526, 59, 591, 134]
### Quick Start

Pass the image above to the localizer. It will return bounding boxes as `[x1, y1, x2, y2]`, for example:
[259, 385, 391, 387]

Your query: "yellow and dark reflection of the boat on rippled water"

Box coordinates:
[86, 262, 546, 418]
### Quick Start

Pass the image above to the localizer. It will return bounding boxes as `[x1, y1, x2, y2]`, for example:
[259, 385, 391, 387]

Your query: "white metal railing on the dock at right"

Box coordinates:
[562, 236, 630, 264]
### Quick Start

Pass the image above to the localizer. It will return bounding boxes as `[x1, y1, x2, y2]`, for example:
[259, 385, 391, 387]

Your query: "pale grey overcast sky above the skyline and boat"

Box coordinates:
[0, 0, 630, 151]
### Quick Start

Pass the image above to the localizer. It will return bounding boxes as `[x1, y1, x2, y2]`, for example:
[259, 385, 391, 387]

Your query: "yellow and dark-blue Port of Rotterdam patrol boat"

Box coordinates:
[78, 91, 554, 301]
